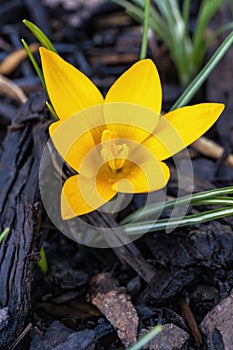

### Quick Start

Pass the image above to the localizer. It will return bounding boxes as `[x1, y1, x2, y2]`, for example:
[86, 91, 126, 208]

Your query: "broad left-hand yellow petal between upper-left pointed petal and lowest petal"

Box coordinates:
[49, 106, 105, 178]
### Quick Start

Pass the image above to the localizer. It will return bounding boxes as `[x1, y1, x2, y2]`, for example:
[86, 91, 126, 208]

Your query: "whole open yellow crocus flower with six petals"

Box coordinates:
[40, 48, 224, 220]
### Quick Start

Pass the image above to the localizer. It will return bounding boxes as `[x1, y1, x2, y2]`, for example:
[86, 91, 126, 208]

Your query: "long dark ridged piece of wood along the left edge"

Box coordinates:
[0, 94, 48, 350]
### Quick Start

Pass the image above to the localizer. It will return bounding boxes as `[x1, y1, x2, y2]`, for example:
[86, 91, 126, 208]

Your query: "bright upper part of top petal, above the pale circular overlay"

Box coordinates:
[105, 59, 162, 114]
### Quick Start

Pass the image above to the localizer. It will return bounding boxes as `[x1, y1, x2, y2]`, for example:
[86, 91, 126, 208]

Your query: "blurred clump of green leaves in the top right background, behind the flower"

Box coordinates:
[112, 0, 224, 86]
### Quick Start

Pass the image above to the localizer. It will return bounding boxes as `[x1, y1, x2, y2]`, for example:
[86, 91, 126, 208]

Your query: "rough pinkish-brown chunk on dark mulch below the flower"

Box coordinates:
[90, 273, 138, 347]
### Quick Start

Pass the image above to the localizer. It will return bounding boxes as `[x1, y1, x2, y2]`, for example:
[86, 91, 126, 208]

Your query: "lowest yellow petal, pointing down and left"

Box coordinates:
[61, 175, 116, 220]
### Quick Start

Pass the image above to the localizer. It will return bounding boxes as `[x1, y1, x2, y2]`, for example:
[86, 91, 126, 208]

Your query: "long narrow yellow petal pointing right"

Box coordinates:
[143, 103, 224, 160]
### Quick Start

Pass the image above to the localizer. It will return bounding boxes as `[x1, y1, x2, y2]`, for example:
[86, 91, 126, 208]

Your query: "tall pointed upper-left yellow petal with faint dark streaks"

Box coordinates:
[40, 48, 103, 119]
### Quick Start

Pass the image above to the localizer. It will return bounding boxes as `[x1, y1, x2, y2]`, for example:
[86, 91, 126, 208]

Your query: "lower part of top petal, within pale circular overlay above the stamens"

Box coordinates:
[104, 103, 159, 143]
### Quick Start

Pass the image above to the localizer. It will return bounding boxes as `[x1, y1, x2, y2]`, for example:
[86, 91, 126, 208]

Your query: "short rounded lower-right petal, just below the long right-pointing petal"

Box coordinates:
[113, 161, 170, 193]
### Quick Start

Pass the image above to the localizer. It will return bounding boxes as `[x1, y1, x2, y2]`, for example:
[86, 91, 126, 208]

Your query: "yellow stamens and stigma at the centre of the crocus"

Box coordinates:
[101, 129, 129, 171]
